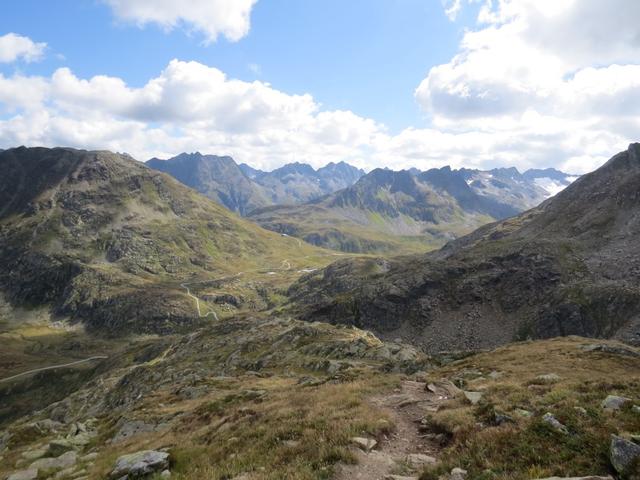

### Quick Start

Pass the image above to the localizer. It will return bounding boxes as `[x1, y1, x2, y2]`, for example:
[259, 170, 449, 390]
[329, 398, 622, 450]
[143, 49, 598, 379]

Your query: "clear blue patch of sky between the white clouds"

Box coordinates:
[0, 0, 470, 131]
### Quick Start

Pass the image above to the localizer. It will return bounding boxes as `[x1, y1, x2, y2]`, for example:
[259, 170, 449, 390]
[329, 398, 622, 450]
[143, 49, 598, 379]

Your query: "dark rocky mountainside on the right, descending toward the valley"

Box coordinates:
[289, 144, 640, 352]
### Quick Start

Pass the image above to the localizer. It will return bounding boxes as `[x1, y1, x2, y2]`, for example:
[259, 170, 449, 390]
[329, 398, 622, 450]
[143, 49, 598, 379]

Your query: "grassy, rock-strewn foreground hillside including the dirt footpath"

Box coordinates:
[0, 328, 640, 480]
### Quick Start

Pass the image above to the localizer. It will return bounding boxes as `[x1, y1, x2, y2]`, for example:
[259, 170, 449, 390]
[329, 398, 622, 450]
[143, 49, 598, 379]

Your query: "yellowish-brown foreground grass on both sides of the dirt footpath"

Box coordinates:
[0, 334, 640, 480]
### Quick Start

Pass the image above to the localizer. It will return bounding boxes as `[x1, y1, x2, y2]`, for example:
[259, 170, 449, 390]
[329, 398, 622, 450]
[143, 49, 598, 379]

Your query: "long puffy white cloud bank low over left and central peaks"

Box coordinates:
[0, 60, 385, 167]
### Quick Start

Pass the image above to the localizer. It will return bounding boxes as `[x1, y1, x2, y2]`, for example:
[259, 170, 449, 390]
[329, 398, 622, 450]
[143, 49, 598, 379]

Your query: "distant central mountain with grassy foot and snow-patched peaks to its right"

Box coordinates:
[249, 167, 575, 253]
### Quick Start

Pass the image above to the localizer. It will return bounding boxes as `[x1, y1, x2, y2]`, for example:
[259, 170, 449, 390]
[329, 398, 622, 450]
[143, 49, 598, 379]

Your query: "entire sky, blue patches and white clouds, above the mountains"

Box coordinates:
[0, 0, 640, 173]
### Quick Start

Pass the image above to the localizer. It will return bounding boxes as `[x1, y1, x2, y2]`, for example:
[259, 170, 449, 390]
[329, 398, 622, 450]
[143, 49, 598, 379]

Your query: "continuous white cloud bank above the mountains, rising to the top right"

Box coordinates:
[0, 0, 640, 173]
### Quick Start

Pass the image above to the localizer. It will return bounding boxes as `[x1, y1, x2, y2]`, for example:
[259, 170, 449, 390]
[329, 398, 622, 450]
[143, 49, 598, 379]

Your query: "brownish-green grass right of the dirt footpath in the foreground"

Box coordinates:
[421, 337, 640, 480]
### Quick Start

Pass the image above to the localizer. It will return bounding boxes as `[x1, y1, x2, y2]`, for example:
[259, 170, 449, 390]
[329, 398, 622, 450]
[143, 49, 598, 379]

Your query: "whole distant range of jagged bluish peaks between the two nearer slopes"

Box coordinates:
[147, 153, 576, 253]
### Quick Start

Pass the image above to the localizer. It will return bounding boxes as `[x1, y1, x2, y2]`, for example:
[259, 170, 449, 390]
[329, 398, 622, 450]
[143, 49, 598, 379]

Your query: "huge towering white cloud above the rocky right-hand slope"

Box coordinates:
[415, 0, 640, 172]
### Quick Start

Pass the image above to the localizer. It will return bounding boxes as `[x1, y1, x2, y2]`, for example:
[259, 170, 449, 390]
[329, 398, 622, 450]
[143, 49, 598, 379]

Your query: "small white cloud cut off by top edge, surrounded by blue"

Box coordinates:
[104, 0, 257, 43]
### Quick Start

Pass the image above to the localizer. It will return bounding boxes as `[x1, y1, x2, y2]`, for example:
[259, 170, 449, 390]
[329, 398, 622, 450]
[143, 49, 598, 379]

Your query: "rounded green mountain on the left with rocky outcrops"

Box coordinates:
[0, 147, 330, 334]
